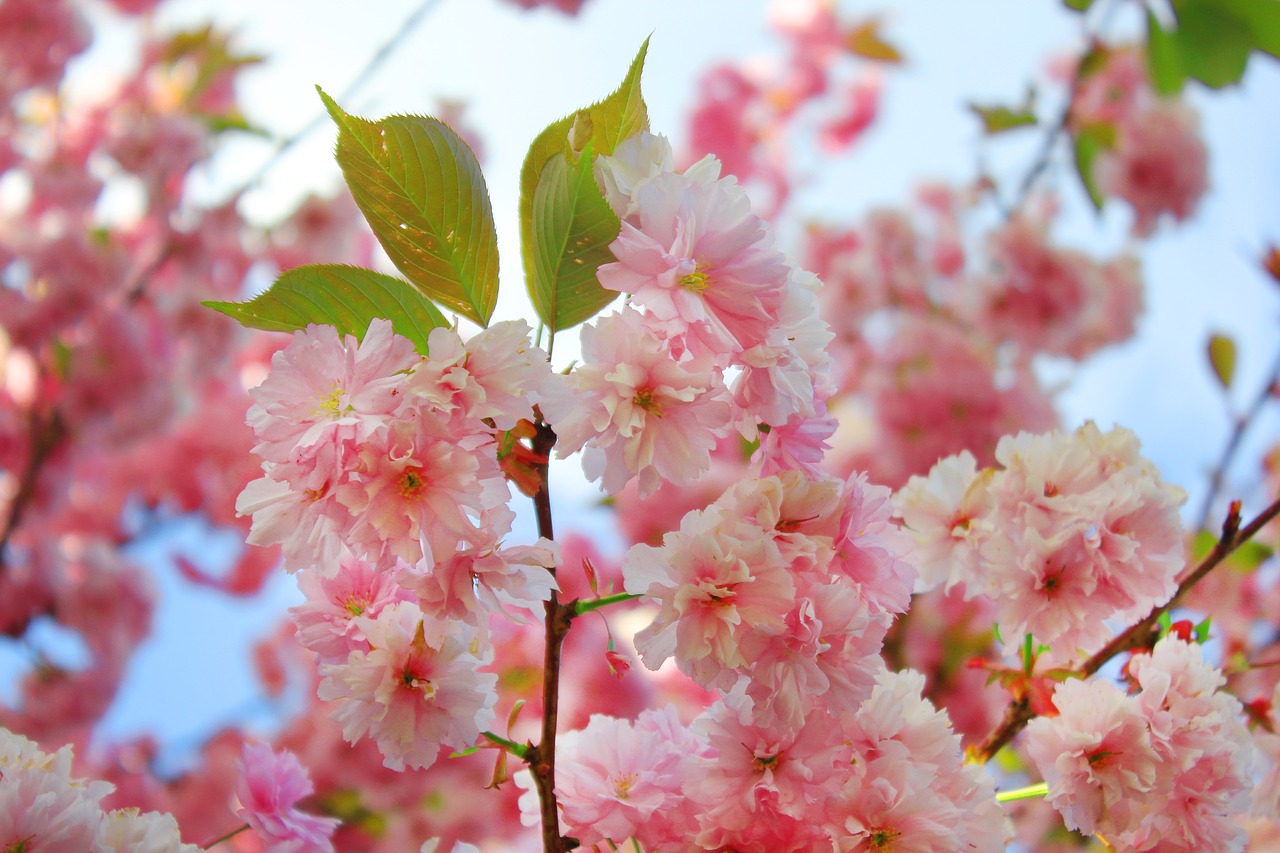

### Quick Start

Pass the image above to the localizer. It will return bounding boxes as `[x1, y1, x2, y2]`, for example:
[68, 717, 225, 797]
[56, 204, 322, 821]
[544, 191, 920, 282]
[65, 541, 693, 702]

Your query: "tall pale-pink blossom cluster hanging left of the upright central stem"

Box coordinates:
[238, 320, 557, 768]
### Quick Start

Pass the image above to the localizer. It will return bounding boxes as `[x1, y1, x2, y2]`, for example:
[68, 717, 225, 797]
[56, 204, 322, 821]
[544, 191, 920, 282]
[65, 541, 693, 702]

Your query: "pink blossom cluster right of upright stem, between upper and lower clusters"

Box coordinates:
[622, 471, 915, 727]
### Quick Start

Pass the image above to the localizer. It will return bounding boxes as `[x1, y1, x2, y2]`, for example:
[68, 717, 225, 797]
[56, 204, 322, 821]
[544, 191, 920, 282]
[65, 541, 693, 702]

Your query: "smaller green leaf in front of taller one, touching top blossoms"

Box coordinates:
[529, 145, 621, 333]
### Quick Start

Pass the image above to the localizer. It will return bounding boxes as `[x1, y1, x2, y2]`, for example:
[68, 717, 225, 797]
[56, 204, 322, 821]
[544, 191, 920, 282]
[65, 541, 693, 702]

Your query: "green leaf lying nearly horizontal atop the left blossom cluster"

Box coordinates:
[204, 258, 449, 355]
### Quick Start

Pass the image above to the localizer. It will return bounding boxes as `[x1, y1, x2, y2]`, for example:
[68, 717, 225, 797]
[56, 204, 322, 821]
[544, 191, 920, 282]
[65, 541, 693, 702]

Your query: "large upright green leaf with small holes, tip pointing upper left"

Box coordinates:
[317, 88, 498, 325]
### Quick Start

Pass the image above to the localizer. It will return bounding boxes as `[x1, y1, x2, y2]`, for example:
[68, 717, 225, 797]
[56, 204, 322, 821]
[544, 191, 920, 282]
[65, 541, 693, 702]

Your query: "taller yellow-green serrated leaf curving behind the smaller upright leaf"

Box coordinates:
[520, 38, 649, 330]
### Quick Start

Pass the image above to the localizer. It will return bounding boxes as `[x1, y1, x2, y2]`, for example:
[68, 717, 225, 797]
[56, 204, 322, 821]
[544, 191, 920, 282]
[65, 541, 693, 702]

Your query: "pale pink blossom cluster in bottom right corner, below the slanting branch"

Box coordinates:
[1027, 637, 1253, 852]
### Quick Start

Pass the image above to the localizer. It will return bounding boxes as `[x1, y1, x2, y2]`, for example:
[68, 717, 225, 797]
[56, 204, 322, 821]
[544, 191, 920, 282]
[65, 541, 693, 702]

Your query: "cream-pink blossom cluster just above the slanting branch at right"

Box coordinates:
[895, 423, 1185, 662]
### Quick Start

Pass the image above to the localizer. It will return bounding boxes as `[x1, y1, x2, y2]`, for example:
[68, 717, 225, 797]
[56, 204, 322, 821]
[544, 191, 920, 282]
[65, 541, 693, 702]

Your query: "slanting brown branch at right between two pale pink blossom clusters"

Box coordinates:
[973, 497, 1280, 763]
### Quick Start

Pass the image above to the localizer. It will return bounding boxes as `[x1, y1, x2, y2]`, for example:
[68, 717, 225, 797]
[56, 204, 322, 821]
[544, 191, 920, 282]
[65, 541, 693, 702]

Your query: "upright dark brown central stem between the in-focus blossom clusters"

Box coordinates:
[526, 420, 577, 853]
